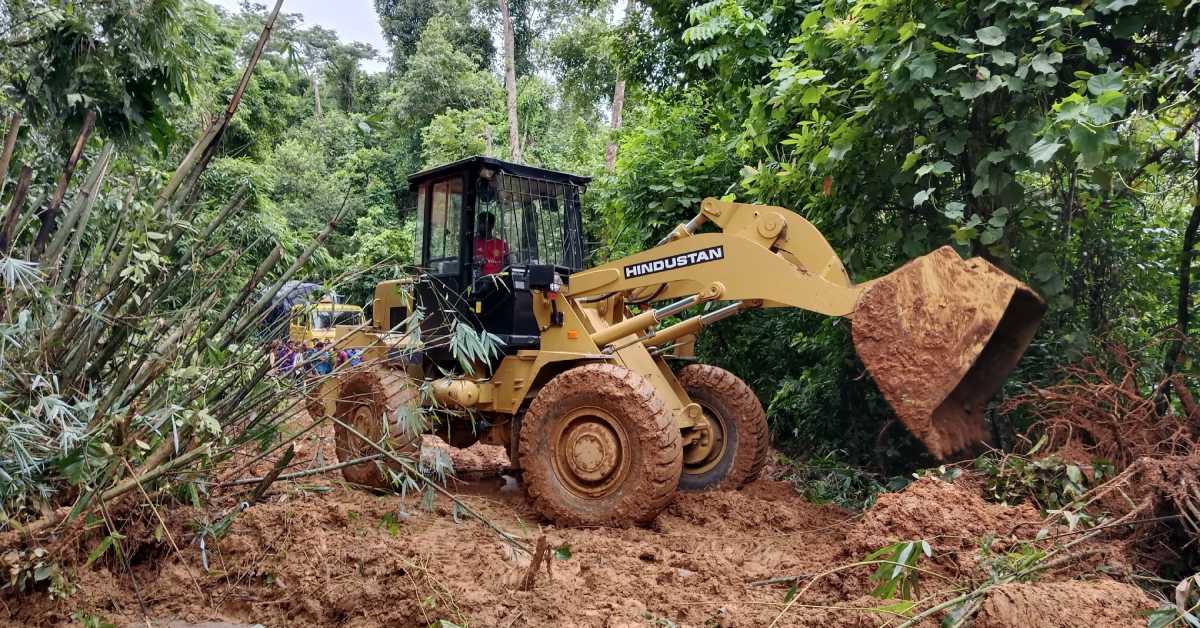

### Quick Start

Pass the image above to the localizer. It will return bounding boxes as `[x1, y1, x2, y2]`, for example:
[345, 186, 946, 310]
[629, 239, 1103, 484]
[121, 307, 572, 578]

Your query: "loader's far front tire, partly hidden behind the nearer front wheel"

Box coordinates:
[676, 364, 770, 491]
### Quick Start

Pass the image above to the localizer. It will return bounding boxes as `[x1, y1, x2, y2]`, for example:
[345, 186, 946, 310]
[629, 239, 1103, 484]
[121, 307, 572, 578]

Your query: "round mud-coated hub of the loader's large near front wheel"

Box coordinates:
[554, 408, 629, 497]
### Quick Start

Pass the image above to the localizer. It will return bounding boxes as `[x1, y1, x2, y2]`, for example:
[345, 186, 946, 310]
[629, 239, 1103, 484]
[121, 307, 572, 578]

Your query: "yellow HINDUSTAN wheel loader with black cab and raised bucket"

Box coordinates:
[314, 157, 1044, 526]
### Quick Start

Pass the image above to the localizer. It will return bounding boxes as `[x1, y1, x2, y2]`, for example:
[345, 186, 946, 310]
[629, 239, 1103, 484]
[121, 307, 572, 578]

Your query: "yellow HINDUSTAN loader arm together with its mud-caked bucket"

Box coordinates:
[564, 198, 1045, 457]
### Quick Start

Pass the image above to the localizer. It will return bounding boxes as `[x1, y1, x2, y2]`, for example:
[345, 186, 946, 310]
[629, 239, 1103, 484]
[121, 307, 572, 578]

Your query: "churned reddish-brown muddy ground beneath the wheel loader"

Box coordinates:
[0, 420, 1156, 628]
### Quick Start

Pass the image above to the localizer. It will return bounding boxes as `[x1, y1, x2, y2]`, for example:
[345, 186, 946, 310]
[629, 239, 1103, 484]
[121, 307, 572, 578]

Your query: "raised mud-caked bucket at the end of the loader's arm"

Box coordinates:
[851, 246, 1045, 459]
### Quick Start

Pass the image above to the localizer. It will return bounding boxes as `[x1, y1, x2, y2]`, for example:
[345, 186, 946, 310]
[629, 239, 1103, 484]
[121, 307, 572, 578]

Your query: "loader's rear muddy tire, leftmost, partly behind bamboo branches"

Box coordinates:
[334, 369, 421, 489]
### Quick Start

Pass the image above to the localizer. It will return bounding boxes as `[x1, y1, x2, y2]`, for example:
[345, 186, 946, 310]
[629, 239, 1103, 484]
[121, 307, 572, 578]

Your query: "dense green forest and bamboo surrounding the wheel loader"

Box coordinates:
[0, 0, 1200, 622]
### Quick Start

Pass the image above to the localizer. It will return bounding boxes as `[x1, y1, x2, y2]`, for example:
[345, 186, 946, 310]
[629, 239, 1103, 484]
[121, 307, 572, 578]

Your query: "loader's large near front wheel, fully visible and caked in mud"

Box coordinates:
[518, 364, 683, 526]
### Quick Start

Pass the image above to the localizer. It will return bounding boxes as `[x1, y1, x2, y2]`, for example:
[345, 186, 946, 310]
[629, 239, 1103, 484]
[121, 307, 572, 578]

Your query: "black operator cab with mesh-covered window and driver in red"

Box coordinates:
[408, 156, 592, 353]
